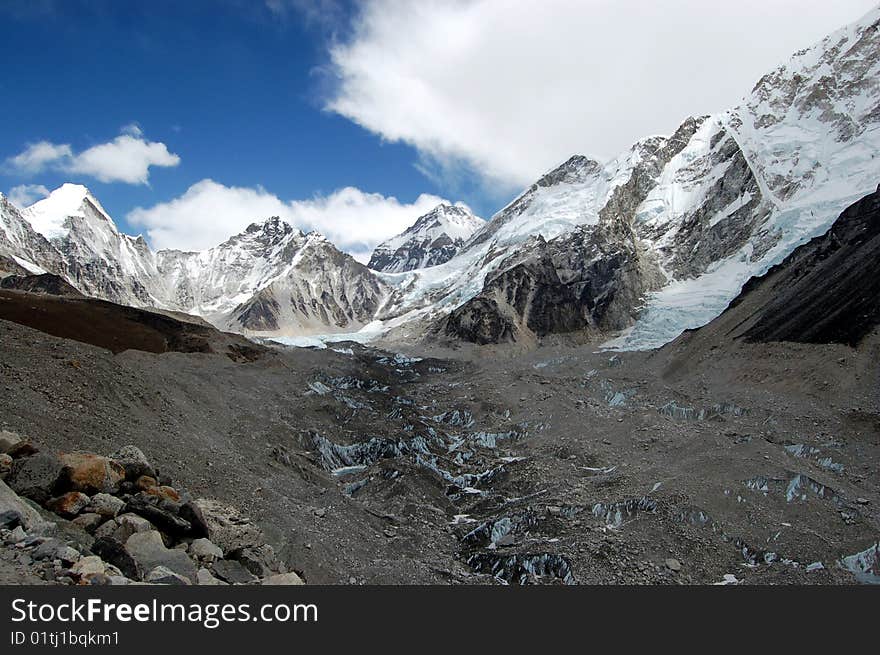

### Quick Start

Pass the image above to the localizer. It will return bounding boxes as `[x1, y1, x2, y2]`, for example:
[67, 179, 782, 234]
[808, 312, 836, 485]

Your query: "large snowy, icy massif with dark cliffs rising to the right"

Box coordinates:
[379, 8, 880, 348]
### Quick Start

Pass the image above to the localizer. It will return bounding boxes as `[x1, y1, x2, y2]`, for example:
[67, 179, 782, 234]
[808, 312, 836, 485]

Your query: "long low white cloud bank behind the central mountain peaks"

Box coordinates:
[126, 179, 460, 261]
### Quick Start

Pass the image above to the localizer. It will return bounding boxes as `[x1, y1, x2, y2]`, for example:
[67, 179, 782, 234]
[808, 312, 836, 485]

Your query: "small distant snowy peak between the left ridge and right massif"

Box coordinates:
[368, 204, 485, 273]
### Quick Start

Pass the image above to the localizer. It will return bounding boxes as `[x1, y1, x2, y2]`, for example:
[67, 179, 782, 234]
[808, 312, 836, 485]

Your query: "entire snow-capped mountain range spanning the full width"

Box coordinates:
[0, 8, 880, 348]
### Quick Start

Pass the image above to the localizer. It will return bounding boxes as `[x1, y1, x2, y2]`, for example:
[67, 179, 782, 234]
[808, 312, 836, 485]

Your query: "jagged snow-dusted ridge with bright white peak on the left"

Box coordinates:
[0, 184, 387, 335]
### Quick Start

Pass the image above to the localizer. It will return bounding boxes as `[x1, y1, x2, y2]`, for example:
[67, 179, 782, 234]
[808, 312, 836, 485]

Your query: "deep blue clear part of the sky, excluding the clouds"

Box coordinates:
[0, 0, 468, 254]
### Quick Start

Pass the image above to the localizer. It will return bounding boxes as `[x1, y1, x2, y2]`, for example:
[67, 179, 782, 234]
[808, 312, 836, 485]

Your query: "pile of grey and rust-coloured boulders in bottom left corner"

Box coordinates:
[0, 431, 303, 585]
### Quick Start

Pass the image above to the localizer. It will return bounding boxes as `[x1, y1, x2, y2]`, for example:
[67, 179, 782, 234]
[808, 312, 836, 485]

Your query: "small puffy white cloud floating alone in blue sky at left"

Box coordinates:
[6, 129, 180, 184]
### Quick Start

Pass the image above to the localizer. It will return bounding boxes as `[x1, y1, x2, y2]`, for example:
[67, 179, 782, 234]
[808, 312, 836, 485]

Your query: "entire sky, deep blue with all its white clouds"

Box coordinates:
[0, 0, 874, 258]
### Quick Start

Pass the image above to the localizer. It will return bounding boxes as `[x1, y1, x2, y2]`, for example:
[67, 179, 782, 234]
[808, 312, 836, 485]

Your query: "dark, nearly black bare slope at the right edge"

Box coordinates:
[727, 187, 880, 346]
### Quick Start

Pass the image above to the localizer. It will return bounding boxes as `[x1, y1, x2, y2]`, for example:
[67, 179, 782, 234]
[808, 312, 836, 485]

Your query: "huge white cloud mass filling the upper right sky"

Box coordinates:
[327, 0, 873, 186]
